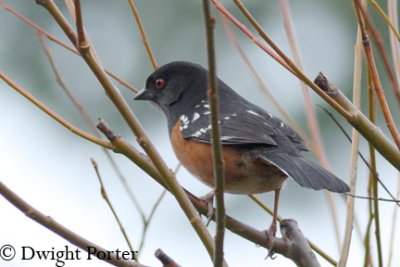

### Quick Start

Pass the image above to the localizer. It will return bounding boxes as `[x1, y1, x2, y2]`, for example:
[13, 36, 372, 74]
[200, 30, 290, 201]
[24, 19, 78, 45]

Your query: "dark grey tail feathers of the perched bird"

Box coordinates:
[261, 153, 350, 193]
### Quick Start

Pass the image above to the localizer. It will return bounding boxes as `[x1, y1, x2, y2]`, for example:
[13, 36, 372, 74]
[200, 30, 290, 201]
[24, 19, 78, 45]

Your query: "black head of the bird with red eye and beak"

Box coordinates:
[134, 61, 207, 129]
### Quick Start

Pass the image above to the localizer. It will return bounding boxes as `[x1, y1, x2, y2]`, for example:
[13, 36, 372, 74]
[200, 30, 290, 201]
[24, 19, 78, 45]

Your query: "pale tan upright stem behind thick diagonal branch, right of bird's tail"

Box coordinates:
[337, 28, 362, 267]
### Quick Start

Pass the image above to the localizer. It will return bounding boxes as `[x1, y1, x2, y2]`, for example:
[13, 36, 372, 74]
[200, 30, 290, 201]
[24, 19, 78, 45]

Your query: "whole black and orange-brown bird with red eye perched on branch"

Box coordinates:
[135, 62, 350, 235]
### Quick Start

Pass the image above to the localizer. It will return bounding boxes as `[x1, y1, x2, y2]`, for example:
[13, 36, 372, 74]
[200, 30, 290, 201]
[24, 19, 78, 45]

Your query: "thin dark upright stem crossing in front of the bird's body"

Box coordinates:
[203, 0, 225, 267]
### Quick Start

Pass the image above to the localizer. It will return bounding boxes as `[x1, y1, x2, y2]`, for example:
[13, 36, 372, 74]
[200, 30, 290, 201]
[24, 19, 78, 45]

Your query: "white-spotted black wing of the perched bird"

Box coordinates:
[180, 101, 307, 150]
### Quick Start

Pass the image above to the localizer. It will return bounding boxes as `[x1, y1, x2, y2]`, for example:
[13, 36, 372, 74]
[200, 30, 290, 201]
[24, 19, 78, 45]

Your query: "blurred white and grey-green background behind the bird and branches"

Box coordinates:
[0, 0, 400, 266]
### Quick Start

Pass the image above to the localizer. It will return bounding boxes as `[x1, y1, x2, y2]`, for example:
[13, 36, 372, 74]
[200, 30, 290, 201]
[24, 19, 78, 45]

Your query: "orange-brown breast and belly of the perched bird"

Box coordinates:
[171, 122, 287, 194]
